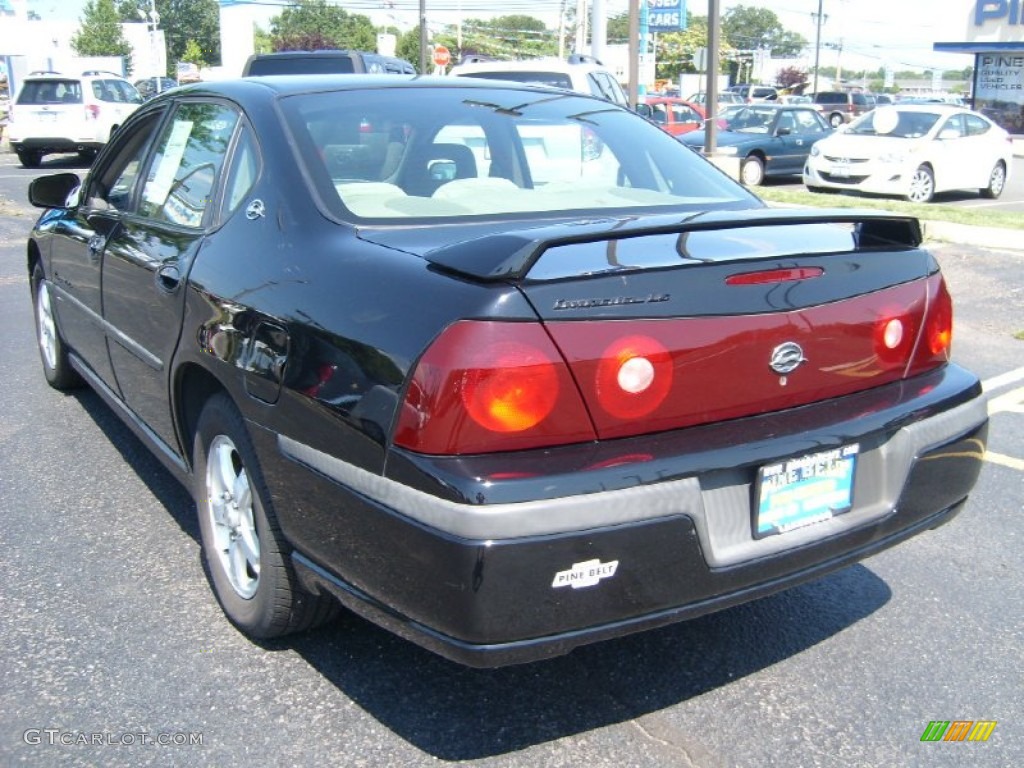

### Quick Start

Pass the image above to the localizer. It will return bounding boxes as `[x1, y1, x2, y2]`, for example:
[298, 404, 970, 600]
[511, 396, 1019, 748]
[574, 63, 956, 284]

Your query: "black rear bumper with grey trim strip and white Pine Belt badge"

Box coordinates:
[270, 366, 987, 667]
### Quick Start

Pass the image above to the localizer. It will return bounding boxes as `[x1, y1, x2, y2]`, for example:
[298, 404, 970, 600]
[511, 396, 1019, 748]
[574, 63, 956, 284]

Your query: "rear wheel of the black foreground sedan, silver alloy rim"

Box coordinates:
[193, 394, 338, 639]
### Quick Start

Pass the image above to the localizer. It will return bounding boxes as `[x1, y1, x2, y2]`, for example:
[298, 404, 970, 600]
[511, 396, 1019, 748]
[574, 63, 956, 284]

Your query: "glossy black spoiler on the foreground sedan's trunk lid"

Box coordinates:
[423, 208, 924, 281]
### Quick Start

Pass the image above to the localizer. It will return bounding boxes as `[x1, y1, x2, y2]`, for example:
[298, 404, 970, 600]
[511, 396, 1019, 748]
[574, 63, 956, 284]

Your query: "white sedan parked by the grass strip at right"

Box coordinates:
[804, 104, 1013, 203]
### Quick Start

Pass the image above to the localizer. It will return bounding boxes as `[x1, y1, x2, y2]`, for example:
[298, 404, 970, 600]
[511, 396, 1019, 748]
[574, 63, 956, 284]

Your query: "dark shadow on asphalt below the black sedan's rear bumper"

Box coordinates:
[289, 552, 892, 761]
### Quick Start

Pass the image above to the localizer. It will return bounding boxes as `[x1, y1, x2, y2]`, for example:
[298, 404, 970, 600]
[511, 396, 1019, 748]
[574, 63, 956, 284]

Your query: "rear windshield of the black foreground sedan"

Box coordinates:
[282, 84, 759, 220]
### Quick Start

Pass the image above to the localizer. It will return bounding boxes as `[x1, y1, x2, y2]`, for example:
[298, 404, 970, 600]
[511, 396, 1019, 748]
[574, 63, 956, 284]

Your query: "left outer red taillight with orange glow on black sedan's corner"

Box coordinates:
[394, 321, 595, 455]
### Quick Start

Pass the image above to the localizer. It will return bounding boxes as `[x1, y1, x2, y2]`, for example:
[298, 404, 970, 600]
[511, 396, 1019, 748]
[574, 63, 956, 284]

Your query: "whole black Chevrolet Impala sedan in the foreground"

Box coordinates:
[27, 76, 987, 666]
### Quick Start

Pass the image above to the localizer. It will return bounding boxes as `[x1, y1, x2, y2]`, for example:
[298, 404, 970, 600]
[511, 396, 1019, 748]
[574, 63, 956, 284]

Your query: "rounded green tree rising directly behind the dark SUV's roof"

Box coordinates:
[270, 0, 377, 50]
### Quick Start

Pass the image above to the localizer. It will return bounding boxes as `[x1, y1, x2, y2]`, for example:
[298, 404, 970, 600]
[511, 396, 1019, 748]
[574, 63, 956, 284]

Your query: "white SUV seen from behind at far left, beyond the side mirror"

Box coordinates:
[7, 71, 142, 168]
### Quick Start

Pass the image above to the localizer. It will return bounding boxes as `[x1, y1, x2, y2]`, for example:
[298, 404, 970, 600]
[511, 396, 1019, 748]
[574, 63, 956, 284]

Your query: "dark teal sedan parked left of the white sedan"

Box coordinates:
[679, 103, 831, 186]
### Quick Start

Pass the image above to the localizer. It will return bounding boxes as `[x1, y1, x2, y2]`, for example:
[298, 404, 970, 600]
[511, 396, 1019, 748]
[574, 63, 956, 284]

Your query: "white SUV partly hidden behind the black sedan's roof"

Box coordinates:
[452, 53, 629, 106]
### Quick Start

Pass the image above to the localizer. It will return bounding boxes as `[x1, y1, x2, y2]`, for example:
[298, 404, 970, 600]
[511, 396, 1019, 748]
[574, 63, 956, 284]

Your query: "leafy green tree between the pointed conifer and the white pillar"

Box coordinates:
[117, 0, 220, 73]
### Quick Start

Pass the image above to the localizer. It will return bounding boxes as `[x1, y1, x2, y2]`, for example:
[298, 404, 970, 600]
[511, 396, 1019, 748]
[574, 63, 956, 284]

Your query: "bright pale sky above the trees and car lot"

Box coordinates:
[27, 0, 974, 71]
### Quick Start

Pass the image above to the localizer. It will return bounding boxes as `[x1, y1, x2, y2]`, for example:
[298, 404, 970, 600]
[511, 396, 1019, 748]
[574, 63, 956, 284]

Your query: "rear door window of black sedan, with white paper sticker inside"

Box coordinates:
[139, 102, 239, 227]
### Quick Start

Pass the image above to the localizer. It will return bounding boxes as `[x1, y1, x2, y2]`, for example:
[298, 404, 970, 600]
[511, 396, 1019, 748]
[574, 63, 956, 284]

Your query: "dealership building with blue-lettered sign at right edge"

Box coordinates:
[932, 0, 1024, 135]
